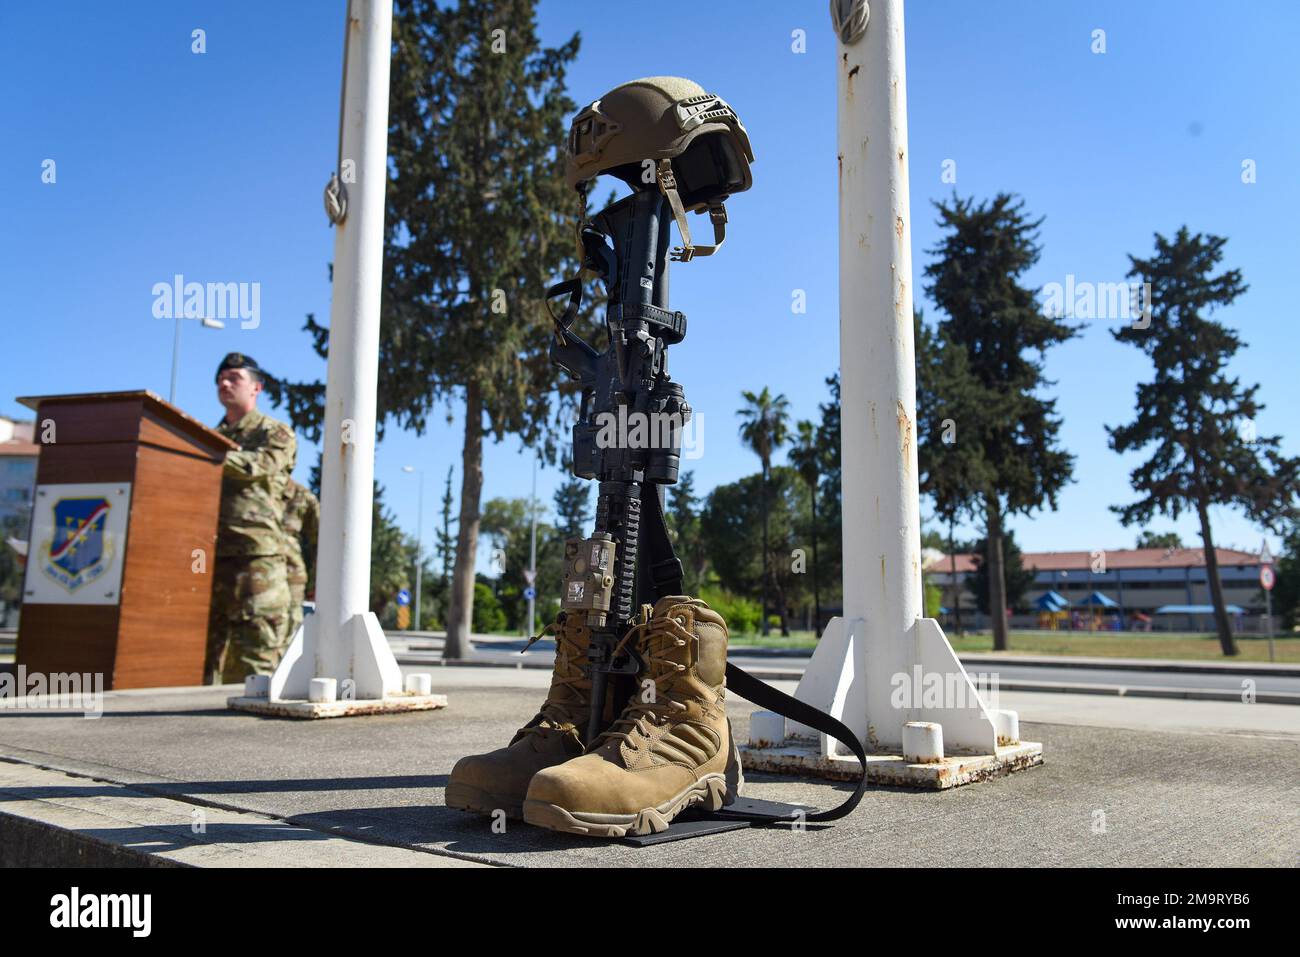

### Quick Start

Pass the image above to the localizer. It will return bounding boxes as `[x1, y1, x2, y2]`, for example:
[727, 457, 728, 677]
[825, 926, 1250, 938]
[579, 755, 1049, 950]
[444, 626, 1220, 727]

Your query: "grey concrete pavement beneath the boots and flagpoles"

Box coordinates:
[0, 667, 1300, 867]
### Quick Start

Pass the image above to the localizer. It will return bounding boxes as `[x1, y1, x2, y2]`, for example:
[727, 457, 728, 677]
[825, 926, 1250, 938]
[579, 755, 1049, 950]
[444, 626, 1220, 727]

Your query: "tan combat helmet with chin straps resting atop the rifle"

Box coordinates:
[564, 77, 754, 261]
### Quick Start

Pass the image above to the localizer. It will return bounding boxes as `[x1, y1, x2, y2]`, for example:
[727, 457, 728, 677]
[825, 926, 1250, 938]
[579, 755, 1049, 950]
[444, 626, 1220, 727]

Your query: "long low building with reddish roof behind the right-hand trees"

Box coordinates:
[926, 549, 1264, 632]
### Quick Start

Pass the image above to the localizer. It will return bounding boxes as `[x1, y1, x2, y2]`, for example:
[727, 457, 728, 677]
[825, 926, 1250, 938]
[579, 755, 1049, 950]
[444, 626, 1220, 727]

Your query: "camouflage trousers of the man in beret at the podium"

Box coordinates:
[204, 555, 293, 684]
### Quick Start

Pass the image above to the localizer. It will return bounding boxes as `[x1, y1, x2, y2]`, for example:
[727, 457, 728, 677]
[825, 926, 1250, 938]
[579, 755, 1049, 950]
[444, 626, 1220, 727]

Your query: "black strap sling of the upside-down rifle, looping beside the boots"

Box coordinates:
[641, 482, 867, 822]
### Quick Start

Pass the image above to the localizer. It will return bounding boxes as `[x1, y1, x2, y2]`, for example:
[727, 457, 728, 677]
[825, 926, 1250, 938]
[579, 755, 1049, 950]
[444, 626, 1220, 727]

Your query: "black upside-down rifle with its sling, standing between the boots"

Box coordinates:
[547, 190, 866, 822]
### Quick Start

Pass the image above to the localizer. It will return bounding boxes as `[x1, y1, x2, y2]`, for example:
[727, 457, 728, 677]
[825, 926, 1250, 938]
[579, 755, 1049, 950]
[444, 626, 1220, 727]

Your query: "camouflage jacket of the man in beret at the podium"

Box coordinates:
[217, 408, 298, 555]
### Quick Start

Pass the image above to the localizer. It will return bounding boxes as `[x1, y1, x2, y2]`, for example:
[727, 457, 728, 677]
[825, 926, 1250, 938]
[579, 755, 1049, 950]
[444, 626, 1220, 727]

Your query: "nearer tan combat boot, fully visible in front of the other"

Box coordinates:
[524, 596, 742, 837]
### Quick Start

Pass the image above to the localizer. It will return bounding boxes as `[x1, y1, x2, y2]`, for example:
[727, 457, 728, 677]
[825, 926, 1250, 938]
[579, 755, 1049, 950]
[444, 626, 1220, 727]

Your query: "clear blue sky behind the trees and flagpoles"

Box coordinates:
[0, 0, 1300, 566]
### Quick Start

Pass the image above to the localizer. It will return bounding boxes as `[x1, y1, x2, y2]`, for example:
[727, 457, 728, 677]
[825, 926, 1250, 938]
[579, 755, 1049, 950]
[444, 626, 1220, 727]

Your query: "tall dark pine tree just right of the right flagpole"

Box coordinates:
[918, 194, 1076, 650]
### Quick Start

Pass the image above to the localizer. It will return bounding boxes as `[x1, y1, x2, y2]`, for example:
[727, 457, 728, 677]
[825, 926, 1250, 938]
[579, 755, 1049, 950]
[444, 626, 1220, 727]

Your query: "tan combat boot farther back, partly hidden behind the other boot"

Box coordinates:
[446, 611, 612, 818]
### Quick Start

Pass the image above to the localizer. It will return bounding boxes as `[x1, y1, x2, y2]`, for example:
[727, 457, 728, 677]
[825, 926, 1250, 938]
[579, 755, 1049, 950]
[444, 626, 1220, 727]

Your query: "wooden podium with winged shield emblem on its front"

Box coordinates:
[17, 391, 237, 689]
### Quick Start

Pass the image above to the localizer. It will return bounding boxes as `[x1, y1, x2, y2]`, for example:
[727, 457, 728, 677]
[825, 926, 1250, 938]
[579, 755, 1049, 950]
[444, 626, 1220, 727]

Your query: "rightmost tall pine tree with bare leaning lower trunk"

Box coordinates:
[1106, 226, 1300, 655]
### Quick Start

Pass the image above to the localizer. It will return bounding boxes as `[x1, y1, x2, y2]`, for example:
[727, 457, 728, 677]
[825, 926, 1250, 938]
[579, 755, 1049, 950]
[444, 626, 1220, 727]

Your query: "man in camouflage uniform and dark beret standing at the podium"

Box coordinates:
[204, 352, 298, 684]
